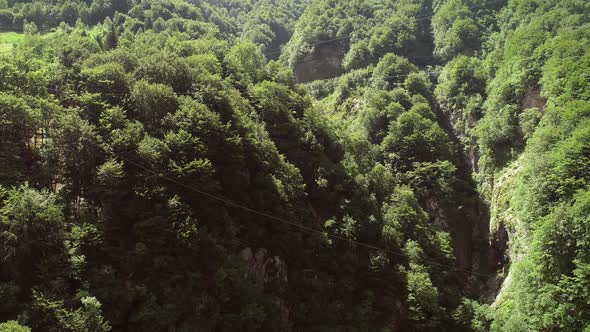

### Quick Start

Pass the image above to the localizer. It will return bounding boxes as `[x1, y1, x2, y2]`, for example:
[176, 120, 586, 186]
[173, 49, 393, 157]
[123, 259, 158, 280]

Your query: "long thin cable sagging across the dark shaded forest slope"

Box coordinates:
[110, 149, 496, 278]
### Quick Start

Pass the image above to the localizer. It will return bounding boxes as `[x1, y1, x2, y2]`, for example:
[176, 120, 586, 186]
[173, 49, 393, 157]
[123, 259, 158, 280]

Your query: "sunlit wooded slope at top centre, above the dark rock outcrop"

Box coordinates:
[283, 0, 430, 71]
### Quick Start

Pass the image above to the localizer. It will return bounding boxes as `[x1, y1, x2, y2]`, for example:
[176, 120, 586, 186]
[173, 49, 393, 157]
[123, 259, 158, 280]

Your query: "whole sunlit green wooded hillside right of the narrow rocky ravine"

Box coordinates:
[470, 1, 588, 331]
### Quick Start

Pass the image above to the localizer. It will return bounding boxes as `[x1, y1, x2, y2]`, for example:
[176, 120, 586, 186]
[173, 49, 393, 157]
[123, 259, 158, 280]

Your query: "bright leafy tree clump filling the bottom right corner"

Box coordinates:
[492, 191, 589, 331]
